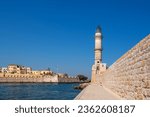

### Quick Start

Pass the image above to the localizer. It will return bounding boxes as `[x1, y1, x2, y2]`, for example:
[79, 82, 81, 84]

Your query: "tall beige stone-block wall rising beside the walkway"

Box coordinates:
[101, 34, 150, 99]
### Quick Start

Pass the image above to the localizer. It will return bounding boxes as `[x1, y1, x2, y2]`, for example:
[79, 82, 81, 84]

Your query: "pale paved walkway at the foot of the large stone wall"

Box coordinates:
[75, 84, 121, 100]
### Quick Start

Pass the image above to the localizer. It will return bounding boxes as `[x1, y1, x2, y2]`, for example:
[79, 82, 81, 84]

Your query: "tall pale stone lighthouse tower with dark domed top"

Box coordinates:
[91, 26, 106, 83]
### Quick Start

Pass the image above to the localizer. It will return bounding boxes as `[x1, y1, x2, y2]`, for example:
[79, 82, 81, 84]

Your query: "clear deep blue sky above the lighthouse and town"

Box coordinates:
[0, 0, 150, 77]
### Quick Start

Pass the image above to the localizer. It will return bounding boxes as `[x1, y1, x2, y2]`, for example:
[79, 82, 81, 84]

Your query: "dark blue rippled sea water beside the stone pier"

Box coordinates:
[0, 83, 80, 100]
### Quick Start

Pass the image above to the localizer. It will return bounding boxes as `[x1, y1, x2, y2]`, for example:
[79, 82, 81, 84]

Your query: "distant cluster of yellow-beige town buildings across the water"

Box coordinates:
[0, 64, 73, 78]
